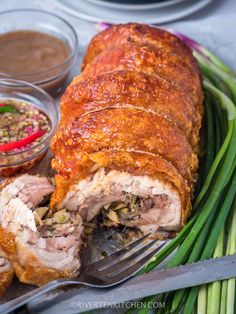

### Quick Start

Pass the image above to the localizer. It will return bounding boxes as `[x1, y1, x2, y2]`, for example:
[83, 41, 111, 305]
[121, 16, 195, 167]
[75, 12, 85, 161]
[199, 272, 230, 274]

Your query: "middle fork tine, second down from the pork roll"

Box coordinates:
[98, 239, 159, 272]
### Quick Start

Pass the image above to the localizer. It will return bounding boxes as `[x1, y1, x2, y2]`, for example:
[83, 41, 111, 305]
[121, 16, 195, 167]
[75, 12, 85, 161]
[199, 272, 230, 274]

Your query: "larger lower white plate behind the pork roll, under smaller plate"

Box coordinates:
[54, 0, 213, 24]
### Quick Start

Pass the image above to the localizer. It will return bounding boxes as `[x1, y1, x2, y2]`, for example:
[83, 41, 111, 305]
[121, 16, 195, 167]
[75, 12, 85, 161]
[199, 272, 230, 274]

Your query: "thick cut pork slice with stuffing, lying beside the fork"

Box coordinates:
[0, 175, 83, 285]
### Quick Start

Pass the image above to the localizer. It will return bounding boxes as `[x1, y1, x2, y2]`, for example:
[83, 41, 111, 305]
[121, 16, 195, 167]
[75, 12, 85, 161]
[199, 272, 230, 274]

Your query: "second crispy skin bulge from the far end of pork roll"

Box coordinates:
[80, 43, 202, 110]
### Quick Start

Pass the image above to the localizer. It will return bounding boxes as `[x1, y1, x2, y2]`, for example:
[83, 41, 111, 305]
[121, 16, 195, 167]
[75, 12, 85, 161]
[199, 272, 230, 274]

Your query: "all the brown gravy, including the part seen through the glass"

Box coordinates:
[0, 30, 72, 95]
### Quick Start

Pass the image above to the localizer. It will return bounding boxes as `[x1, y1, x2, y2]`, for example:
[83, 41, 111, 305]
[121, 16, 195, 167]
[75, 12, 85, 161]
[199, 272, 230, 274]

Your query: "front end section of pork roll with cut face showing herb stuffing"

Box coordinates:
[52, 150, 190, 233]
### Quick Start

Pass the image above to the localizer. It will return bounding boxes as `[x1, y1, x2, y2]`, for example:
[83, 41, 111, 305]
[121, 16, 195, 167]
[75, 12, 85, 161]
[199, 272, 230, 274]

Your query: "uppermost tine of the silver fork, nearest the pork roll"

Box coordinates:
[86, 233, 150, 268]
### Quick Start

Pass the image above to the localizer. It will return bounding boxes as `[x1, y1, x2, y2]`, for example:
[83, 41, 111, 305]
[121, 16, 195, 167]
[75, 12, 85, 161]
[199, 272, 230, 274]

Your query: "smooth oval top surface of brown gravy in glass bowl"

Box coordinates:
[0, 30, 71, 75]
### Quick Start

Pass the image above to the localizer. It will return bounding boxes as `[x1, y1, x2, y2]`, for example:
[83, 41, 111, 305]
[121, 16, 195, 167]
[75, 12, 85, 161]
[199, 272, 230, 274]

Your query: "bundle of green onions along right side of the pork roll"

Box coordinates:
[128, 33, 236, 314]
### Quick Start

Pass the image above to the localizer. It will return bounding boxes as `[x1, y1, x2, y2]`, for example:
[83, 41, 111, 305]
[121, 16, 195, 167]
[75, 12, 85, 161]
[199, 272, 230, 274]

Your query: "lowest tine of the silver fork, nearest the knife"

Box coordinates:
[106, 242, 166, 283]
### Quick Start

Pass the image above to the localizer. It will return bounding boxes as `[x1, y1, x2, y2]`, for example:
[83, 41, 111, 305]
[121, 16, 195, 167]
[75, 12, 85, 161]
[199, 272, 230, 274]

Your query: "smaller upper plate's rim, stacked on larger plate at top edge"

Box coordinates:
[87, 0, 188, 11]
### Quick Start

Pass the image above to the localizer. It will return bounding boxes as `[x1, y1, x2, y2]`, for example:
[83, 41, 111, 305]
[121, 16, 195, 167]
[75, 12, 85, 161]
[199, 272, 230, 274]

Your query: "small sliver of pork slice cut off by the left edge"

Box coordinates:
[0, 256, 14, 298]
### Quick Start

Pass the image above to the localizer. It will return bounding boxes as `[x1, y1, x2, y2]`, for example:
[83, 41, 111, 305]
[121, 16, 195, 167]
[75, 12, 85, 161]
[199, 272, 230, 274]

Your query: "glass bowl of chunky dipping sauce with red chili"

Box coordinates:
[0, 79, 59, 176]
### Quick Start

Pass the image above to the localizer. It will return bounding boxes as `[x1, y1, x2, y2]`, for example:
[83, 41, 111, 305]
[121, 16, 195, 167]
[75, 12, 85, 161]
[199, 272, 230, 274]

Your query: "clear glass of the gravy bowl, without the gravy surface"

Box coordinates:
[0, 9, 78, 96]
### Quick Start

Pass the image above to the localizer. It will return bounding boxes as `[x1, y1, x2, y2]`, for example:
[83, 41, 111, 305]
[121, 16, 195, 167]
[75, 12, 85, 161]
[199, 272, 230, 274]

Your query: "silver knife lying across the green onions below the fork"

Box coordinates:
[28, 254, 236, 314]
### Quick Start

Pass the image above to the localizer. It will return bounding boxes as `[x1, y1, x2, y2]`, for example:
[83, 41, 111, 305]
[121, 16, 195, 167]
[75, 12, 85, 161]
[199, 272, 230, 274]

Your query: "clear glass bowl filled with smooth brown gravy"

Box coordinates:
[0, 9, 78, 96]
